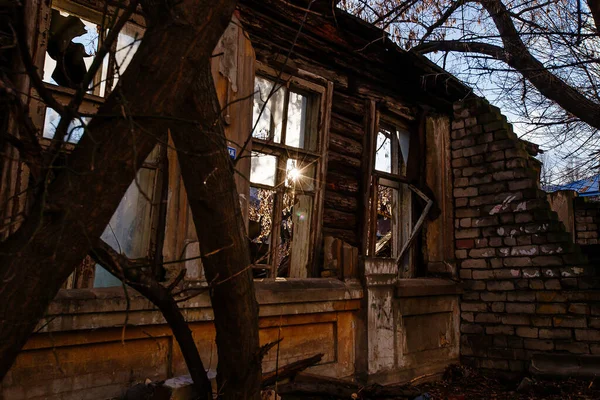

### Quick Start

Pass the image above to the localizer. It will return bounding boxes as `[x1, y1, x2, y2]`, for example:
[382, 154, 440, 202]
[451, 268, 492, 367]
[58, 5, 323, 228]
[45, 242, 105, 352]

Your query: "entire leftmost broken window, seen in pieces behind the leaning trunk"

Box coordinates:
[40, 0, 166, 288]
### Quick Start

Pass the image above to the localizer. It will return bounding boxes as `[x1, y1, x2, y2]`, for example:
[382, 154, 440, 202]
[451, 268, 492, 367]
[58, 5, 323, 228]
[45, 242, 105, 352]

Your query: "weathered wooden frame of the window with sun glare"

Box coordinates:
[248, 62, 330, 279]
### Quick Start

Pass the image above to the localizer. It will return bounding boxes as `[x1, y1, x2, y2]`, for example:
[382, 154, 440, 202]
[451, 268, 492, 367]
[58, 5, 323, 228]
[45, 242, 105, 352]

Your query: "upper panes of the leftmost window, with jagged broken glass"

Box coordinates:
[42, 0, 144, 143]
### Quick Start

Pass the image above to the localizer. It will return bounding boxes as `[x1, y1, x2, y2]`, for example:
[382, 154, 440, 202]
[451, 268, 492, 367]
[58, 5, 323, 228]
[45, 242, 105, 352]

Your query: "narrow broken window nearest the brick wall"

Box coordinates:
[367, 121, 412, 262]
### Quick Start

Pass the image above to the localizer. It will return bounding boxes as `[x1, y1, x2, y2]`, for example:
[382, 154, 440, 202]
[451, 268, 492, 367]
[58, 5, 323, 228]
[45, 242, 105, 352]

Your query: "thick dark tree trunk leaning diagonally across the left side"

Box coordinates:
[0, 0, 239, 380]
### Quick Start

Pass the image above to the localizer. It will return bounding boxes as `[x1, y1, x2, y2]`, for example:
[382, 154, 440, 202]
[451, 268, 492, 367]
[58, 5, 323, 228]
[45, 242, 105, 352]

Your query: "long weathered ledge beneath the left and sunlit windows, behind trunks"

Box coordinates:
[43, 278, 363, 332]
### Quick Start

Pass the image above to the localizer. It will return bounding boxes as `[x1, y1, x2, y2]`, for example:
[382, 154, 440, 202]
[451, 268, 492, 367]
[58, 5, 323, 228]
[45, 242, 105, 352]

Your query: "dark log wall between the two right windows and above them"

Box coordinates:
[232, 1, 424, 256]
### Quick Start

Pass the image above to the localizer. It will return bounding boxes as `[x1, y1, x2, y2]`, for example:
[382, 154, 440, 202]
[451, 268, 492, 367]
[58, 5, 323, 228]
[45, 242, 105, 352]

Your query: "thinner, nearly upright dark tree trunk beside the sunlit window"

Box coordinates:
[171, 65, 261, 399]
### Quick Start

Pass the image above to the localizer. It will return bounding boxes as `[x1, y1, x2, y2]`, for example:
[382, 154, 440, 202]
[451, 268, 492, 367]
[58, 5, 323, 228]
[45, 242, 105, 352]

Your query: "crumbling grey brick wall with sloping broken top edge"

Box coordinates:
[452, 99, 600, 372]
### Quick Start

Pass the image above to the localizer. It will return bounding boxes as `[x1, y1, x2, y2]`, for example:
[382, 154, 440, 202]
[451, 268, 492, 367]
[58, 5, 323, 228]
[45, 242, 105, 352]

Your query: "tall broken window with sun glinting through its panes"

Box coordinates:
[248, 76, 319, 277]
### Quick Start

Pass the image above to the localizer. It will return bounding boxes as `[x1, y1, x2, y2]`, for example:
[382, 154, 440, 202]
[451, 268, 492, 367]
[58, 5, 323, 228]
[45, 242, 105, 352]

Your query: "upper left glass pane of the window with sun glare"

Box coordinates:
[252, 76, 285, 143]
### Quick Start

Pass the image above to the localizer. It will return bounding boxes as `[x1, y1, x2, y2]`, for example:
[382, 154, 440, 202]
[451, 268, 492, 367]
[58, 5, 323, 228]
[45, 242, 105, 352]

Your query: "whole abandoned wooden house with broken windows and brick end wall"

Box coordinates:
[0, 0, 600, 400]
